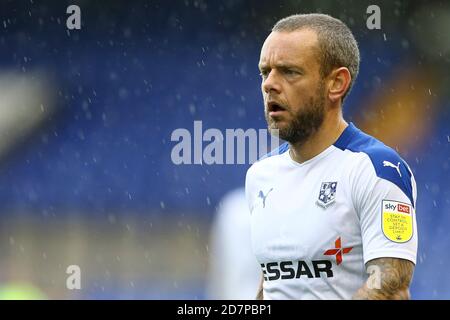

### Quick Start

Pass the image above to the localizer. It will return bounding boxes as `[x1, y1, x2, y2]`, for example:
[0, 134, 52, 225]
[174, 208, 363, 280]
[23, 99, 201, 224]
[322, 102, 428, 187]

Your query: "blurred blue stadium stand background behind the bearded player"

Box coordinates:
[0, 0, 450, 299]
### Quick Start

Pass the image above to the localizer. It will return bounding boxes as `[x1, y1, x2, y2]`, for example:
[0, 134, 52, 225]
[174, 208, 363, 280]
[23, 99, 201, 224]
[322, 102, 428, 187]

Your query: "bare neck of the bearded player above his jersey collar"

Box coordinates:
[289, 113, 348, 163]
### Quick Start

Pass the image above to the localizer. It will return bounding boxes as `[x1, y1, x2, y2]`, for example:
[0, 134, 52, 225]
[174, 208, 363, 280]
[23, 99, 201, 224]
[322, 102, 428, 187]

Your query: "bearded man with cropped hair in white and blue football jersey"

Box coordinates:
[246, 14, 417, 299]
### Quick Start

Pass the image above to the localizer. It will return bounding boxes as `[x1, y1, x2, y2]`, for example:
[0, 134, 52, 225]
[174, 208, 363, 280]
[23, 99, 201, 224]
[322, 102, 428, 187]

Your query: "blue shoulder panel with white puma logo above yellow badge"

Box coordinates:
[334, 122, 414, 206]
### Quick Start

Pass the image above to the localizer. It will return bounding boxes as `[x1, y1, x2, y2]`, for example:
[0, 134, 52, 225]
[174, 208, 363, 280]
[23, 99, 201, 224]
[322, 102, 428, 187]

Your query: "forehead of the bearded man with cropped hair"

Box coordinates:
[259, 29, 319, 65]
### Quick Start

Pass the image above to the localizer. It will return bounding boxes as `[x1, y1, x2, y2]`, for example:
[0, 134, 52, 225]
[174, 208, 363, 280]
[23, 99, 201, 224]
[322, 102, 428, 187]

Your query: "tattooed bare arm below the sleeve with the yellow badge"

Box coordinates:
[353, 258, 414, 300]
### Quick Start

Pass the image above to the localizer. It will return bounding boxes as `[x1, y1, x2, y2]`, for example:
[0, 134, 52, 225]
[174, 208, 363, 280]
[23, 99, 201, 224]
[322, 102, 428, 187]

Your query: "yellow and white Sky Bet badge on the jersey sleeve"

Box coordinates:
[381, 200, 413, 243]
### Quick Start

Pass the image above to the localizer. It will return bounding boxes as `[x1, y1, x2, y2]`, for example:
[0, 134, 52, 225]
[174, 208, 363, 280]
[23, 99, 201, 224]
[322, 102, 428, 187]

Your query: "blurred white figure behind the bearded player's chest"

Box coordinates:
[206, 188, 260, 300]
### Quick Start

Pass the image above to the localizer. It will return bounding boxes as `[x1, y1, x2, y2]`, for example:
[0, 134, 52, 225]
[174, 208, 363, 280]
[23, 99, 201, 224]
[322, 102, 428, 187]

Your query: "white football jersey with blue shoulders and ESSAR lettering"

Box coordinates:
[246, 123, 417, 299]
